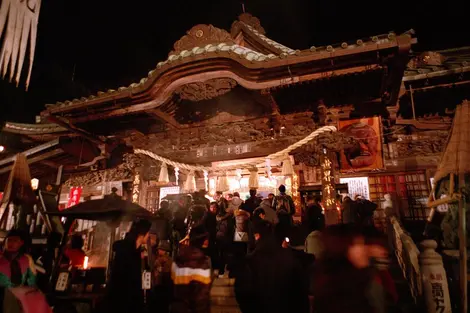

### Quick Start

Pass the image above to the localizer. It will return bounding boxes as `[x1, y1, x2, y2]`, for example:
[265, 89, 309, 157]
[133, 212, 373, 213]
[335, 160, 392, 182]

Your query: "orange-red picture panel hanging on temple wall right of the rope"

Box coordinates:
[338, 117, 384, 171]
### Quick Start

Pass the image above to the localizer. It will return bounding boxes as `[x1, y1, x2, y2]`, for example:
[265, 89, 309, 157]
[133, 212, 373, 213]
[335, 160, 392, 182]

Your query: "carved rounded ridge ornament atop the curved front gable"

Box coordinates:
[169, 24, 235, 55]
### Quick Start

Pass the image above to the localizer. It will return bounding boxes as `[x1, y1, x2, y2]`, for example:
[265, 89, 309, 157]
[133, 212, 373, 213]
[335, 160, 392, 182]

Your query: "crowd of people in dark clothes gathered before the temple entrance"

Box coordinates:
[107, 186, 397, 313]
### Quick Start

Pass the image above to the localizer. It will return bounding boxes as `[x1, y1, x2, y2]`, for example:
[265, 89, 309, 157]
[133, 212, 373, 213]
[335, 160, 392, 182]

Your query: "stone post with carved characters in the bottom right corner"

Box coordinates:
[419, 240, 452, 313]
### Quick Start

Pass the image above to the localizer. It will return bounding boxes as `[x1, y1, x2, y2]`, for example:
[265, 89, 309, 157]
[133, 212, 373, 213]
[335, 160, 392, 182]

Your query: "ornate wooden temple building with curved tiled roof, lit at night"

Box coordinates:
[0, 13, 470, 225]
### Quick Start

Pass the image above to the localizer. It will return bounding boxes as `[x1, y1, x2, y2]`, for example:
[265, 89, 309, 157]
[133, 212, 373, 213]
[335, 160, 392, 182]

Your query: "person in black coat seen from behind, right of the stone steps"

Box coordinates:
[235, 221, 309, 313]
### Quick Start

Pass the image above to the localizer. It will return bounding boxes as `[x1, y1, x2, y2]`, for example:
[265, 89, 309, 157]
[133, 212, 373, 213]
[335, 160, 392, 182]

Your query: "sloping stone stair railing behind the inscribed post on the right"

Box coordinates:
[388, 216, 423, 304]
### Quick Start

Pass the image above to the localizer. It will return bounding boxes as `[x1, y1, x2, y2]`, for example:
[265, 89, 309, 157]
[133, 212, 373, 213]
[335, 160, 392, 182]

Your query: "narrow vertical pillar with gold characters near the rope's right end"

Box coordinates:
[320, 149, 339, 226]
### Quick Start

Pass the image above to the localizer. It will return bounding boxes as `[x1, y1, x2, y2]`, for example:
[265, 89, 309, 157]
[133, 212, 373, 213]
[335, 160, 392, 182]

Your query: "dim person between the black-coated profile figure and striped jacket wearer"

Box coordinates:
[150, 240, 173, 313]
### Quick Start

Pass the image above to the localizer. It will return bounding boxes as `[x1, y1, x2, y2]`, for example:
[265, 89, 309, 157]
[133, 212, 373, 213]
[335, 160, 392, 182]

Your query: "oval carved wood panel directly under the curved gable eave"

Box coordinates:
[176, 78, 237, 101]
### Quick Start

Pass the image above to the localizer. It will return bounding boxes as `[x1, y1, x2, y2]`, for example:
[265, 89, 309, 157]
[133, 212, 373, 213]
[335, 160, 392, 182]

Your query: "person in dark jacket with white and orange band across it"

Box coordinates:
[171, 225, 212, 313]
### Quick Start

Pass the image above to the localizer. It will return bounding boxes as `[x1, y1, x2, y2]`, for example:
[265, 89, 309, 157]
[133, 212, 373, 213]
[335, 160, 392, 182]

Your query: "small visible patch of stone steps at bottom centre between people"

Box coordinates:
[211, 277, 241, 313]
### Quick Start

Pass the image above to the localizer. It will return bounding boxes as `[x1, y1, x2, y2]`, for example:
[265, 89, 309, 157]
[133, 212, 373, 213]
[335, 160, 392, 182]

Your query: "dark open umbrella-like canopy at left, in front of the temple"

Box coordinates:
[47, 196, 152, 221]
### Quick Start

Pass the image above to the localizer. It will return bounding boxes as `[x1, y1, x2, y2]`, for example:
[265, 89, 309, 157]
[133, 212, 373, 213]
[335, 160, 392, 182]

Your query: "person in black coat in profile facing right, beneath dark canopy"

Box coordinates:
[105, 220, 151, 313]
